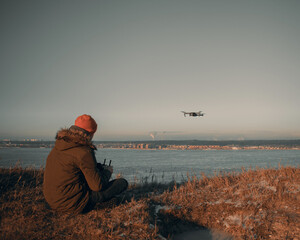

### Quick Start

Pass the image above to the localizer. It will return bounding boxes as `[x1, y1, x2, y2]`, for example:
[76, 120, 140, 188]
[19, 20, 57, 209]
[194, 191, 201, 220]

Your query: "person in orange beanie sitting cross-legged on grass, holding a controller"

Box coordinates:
[43, 114, 128, 213]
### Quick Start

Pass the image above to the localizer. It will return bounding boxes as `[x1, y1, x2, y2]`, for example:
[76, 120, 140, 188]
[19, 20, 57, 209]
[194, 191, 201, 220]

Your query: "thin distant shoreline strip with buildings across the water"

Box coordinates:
[0, 140, 300, 150]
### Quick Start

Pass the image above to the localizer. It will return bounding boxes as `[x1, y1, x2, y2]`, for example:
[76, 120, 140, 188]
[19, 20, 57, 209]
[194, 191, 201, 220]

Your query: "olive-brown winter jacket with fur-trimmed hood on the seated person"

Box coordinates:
[43, 128, 111, 213]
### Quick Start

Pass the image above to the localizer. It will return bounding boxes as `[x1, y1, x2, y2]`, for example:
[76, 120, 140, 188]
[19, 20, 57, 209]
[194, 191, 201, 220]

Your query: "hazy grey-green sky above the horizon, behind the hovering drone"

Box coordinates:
[0, 0, 300, 140]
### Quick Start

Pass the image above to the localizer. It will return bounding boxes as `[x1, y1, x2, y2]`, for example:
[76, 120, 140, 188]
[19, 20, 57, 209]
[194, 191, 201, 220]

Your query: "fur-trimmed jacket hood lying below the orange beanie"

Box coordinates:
[55, 128, 97, 150]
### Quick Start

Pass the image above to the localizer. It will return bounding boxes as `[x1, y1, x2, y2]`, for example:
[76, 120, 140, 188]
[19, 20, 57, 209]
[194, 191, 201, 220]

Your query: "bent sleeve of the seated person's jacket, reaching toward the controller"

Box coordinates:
[79, 152, 111, 192]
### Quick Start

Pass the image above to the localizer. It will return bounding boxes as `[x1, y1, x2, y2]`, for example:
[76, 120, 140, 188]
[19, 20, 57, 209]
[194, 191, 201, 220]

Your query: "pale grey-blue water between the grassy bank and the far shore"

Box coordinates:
[0, 147, 300, 183]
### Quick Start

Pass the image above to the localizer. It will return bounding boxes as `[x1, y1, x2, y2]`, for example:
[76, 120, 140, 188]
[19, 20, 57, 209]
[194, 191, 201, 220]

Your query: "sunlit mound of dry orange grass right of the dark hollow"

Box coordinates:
[156, 167, 300, 239]
